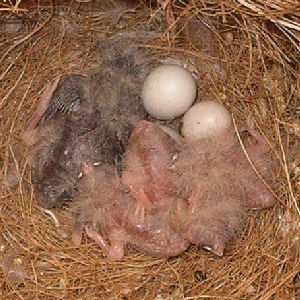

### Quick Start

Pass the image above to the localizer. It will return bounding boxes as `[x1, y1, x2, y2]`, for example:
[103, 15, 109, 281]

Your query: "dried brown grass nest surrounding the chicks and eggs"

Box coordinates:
[0, 0, 300, 299]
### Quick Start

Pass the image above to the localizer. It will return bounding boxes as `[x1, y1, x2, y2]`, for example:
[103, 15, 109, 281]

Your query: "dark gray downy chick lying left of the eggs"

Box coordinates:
[22, 36, 149, 208]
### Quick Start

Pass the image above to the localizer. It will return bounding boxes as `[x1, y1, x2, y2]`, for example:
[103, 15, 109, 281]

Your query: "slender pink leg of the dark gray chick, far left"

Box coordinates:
[21, 78, 59, 146]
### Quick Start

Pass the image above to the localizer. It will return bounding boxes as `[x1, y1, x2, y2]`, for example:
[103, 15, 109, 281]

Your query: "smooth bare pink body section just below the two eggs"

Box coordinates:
[122, 121, 179, 220]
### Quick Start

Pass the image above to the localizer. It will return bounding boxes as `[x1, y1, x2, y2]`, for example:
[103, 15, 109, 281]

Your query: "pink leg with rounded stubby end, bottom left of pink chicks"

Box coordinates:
[85, 225, 124, 261]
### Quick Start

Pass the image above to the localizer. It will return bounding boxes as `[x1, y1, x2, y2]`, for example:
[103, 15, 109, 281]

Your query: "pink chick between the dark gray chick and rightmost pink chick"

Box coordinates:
[73, 121, 190, 260]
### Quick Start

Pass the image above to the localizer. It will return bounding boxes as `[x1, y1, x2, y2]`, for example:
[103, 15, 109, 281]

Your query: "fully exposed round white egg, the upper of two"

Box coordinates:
[142, 65, 197, 120]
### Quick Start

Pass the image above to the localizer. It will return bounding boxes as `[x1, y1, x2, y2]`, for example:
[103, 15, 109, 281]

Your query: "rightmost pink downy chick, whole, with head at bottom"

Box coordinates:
[173, 119, 275, 256]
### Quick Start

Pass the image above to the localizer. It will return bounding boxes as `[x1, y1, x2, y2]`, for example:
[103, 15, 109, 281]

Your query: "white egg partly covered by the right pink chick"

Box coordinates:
[182, 101, 232, 142]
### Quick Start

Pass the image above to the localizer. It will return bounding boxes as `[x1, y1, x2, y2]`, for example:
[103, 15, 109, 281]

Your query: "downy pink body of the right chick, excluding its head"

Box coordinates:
[174, 120, 275, 209]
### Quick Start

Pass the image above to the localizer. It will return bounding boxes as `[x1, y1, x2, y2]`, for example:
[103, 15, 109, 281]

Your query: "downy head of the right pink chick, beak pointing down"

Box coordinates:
[170, 199, 243, 256]
